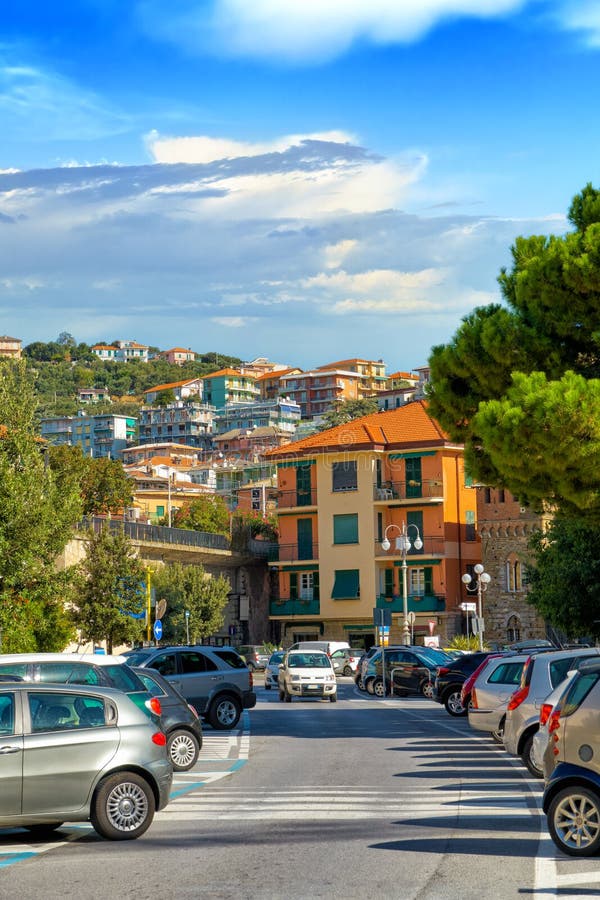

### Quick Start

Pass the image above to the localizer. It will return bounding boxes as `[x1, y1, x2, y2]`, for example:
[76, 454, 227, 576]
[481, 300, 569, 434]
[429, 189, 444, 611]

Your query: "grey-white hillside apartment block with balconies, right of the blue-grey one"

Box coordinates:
[138, 399, 215, 450]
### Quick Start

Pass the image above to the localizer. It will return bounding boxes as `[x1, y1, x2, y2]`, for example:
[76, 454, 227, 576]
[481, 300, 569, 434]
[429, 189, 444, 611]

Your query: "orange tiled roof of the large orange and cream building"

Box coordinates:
[265, 400, 450, 459]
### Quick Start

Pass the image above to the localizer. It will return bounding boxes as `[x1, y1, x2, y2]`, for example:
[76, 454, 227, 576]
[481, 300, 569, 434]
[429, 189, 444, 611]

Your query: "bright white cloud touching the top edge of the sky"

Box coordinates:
[138, 0, 528, 63]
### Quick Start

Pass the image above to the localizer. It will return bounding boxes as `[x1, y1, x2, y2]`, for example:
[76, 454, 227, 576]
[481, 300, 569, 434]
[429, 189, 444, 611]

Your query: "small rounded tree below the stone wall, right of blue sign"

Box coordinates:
[153, 563, 231, 644]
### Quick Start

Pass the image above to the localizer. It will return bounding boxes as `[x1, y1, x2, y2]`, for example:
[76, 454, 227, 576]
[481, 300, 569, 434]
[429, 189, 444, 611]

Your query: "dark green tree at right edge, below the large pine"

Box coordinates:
[527, 517, 600, 639]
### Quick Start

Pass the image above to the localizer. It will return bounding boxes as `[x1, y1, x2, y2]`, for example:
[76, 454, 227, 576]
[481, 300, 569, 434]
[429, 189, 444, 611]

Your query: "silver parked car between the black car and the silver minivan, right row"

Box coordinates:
[468, 653, 529, 741]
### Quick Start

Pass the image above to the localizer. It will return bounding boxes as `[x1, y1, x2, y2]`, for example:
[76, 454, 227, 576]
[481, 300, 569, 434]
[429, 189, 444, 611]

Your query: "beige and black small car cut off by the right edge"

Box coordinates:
[543, 659, 600, 856]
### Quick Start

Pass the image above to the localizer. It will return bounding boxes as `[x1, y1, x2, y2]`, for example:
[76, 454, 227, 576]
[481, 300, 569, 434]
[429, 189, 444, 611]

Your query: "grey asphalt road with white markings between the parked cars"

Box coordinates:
[0, 678, 600, 900]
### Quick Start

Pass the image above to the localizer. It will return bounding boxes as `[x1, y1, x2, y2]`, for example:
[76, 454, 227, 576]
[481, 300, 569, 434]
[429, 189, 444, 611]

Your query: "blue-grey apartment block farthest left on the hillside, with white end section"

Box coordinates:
[40, 414, 137, 459]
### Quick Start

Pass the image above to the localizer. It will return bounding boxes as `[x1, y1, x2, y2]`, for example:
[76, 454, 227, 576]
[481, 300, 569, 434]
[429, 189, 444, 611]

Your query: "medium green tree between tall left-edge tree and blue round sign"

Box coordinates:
[73, 524, 147, 653]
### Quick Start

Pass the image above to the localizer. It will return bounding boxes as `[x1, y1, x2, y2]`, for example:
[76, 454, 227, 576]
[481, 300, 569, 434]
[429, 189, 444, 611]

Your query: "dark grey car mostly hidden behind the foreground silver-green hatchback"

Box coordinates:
[133, 668, 202, 772]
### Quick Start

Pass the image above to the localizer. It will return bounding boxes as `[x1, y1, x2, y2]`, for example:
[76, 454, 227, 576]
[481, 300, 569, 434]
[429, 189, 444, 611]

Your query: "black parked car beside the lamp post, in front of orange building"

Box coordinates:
[363, 646, 451, 698]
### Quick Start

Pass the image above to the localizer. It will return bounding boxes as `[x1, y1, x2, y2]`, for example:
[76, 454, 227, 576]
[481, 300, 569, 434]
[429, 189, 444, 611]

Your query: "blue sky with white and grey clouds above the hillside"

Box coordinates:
[0, 0, 600, 371]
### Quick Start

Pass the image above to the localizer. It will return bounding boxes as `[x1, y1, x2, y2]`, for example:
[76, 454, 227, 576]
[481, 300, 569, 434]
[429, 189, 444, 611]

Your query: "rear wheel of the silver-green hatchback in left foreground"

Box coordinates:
[90, 772, 156, 841]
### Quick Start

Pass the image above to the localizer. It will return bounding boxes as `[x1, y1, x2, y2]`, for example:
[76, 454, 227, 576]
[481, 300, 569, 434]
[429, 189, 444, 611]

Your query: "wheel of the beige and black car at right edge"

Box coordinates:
[547, 784, 600, 856]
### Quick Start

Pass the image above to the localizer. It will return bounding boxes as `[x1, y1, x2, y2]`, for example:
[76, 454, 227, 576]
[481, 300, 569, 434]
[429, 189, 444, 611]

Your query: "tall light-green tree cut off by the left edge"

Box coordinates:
[0, 360, 81, 652]
